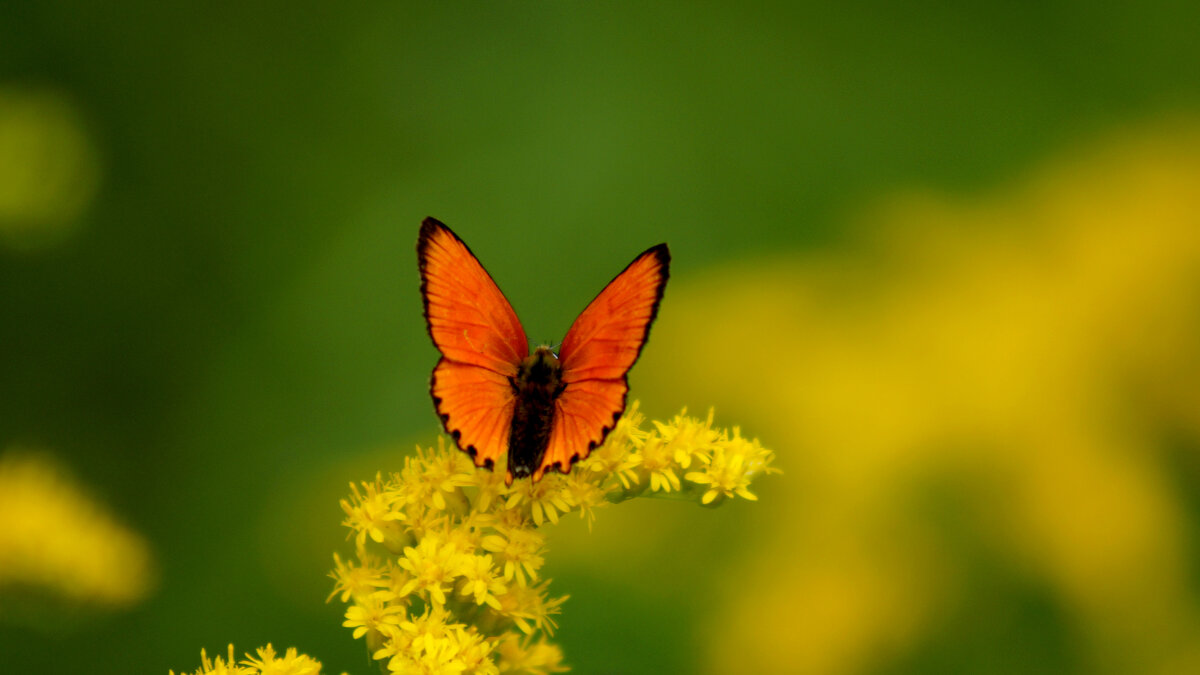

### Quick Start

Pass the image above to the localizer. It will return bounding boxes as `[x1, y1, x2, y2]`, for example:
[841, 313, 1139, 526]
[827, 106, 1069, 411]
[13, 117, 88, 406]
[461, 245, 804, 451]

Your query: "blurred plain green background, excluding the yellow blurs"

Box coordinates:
[0, 1, 1200, 673]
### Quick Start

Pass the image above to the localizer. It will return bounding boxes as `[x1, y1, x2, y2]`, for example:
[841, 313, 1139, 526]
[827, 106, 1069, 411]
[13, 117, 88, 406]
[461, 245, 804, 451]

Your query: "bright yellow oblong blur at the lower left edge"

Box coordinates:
[0, 449, 151, 608]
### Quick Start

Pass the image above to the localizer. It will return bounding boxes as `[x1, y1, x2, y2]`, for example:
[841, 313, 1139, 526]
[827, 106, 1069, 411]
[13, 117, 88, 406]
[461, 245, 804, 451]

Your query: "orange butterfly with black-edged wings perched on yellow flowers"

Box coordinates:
[416, 217, 671, 485]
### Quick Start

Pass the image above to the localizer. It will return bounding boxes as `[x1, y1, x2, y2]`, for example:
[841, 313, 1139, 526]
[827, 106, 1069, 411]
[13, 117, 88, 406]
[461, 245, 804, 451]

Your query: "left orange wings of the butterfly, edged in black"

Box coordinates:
[416, 217, 529, 467]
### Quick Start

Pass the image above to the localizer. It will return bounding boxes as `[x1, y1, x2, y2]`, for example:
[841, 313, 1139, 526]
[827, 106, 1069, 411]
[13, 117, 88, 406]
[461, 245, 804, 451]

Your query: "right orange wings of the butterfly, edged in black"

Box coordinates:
[533, 244, 671, 480]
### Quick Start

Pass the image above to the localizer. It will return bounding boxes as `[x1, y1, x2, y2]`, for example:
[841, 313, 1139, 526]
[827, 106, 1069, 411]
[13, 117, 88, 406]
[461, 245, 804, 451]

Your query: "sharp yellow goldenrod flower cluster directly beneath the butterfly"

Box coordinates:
[330, 402, 778, 675]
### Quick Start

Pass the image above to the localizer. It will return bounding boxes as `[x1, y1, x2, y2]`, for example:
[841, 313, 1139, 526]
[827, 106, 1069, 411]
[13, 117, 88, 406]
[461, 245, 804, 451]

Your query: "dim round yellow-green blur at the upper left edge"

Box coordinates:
[0, 86, 100, 249]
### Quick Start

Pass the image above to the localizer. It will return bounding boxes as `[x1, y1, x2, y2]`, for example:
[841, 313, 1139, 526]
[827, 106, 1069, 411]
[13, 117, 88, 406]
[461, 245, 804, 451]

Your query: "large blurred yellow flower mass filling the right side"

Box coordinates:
[640, 120, 1200, 673]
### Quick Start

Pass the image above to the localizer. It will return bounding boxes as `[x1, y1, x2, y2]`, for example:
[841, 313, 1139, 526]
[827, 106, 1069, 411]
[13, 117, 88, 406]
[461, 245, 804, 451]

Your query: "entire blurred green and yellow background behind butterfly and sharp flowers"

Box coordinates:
[0, 1, 1200, 675]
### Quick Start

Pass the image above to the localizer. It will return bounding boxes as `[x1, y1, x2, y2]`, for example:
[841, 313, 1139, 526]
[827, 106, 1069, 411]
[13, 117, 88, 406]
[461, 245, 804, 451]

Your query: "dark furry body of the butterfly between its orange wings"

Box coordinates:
[509, 347, 563, 478]
